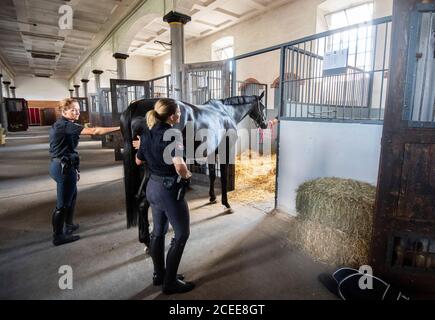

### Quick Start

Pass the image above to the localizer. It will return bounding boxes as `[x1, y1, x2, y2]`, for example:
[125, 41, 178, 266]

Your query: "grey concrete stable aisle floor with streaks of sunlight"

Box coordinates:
[0, 127, 336, 300]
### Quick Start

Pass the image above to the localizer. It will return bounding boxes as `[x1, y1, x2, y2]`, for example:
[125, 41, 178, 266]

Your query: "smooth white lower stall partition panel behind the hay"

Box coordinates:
[278, 120, 382, 215]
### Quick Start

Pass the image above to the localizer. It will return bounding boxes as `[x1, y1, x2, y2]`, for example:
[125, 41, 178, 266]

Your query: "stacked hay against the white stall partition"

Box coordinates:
[293, 178, 376, 267]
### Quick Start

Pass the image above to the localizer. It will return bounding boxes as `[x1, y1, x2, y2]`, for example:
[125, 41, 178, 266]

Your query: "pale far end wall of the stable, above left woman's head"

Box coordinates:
[14, 77, 69, 100]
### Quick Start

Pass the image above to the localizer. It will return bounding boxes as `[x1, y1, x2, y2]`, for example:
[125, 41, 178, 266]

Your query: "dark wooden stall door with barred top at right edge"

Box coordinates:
[372, 0, 435, 296]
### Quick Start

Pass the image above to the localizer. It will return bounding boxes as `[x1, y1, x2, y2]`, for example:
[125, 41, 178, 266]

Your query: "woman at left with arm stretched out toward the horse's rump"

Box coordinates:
[50, 99, 119, 246]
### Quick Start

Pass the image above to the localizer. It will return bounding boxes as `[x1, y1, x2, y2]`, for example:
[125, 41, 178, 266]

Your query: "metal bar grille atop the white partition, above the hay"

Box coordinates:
[281, 18, 391, 123]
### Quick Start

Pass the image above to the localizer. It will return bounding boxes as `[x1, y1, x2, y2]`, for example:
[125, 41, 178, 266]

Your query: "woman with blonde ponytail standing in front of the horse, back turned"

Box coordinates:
[133, 99, 194, 294]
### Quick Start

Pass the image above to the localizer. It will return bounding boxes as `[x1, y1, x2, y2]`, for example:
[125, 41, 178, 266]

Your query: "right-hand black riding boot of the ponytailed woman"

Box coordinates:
[163, 239, 195, 294]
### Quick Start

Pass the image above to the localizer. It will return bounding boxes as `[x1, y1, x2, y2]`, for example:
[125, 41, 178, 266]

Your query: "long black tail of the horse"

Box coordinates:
[120, 102, 140, 228]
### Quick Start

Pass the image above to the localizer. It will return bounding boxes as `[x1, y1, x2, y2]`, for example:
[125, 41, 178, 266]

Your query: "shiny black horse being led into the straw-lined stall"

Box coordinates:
[121, 92, 267, 246]
